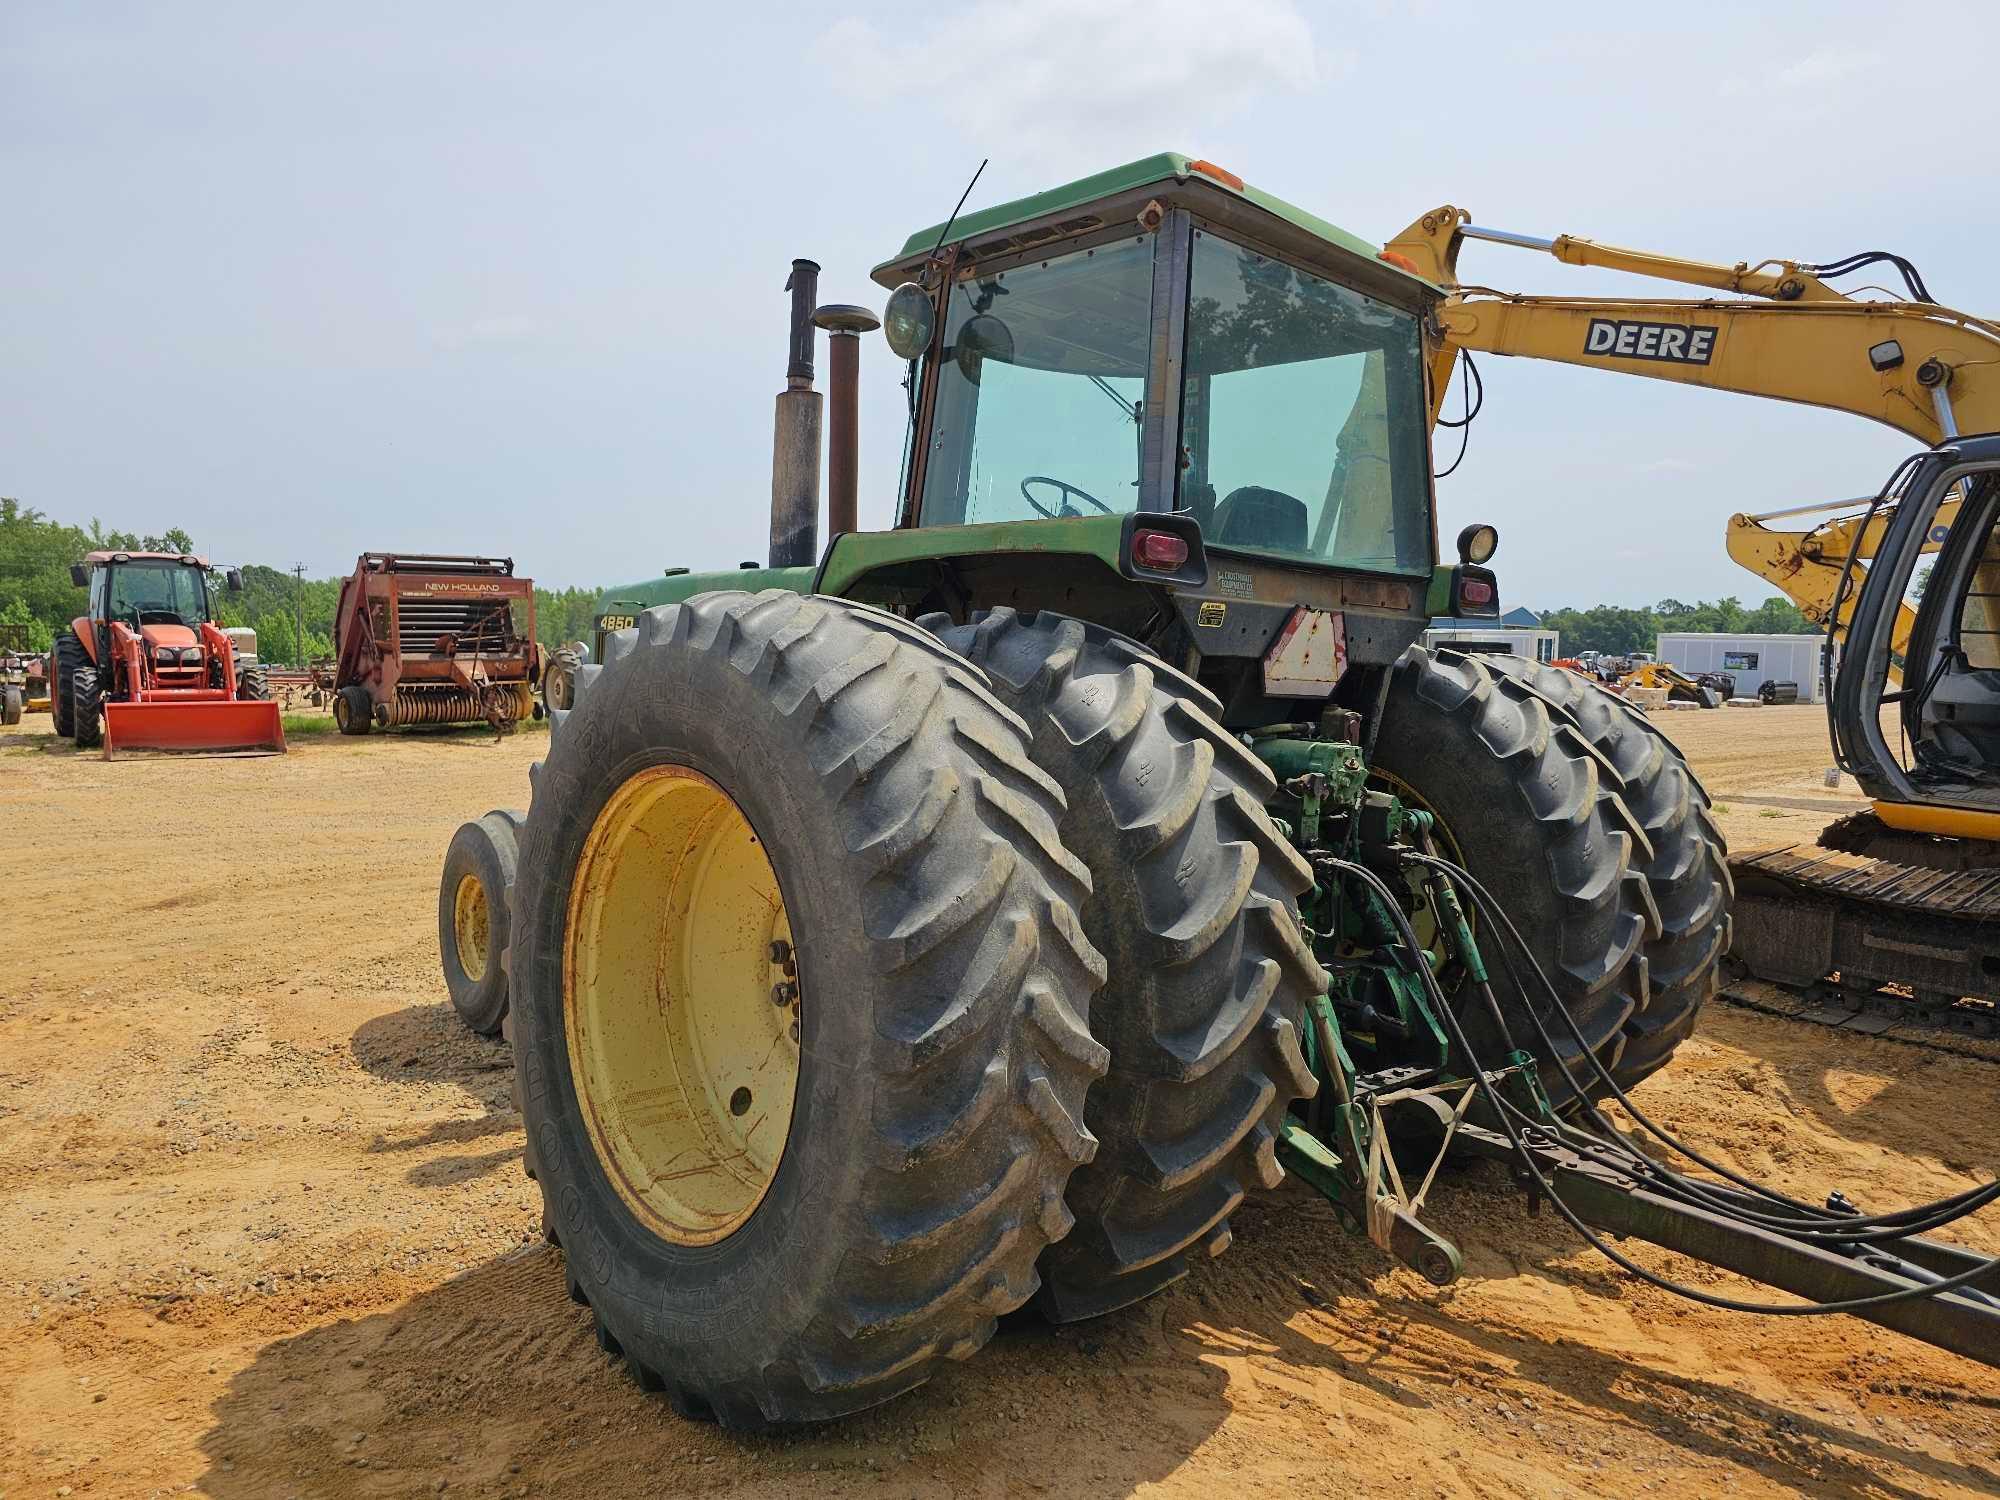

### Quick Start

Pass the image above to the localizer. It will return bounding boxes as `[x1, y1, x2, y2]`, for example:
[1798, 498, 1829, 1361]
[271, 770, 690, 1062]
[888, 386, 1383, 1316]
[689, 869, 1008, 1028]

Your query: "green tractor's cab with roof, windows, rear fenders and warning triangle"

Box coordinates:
[826, 156, 1498, 722]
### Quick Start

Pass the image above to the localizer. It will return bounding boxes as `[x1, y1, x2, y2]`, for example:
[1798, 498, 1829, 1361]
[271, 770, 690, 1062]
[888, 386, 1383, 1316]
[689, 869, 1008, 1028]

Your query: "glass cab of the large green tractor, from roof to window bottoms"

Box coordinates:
[876, 156, 1434, 578]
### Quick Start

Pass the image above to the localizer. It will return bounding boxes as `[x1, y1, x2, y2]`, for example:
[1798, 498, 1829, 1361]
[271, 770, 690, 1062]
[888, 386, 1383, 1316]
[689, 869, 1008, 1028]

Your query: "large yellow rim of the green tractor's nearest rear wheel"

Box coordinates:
[562, 766, 800, 1244]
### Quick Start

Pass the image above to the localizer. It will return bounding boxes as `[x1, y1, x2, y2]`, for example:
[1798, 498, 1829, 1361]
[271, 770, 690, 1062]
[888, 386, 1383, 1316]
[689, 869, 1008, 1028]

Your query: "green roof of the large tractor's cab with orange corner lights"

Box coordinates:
[872, 152, 1436, 290]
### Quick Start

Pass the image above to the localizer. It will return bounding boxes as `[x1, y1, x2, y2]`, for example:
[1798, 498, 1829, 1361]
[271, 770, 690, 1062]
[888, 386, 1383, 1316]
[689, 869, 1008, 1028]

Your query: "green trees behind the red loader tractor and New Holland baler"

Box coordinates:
[0, 496, 602, 666]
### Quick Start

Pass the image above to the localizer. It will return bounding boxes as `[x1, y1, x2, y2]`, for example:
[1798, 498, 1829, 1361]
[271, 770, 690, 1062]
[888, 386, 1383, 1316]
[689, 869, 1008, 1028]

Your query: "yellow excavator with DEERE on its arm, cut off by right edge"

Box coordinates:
[1382, 206, 2000, 1036]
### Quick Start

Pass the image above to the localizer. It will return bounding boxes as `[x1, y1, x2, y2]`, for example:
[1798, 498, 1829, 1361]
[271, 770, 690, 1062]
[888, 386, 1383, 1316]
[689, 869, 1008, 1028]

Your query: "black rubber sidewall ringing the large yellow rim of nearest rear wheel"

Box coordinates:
[512, 628, 876, 1378]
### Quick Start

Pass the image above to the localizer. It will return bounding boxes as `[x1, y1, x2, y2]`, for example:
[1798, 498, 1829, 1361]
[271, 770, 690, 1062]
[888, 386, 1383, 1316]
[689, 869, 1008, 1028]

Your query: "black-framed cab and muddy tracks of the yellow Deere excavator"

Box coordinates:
[1732, 434, 2000, 1036]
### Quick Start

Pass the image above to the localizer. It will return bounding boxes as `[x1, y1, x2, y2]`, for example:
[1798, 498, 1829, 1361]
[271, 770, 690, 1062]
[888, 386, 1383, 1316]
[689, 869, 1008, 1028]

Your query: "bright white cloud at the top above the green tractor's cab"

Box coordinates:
[822, 0, 1348, 154]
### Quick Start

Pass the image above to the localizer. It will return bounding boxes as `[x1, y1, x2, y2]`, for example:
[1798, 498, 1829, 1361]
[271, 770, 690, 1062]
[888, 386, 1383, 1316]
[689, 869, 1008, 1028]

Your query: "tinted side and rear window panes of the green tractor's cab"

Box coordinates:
[922, 230, 1432, 574]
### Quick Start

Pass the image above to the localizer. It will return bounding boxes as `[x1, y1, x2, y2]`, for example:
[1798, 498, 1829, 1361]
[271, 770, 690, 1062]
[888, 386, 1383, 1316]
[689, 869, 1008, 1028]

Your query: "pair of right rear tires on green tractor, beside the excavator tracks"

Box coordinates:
[1370, 646, 1732, 1110]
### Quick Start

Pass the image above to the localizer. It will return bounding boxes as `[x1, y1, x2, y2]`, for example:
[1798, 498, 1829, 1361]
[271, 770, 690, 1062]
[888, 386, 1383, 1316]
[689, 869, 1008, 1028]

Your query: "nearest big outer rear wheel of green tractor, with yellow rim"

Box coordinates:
[508, 592, 1106, 1428]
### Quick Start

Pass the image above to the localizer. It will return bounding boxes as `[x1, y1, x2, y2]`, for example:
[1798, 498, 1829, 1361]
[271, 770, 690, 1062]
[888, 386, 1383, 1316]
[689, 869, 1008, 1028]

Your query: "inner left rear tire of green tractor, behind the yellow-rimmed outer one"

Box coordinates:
[926, 608, 1326, 1322]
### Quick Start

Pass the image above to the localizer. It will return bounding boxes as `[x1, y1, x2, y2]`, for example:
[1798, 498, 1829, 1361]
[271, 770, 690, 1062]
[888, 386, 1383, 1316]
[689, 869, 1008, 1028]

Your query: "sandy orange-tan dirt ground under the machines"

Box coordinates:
[0, 708, 2000, 1500]
